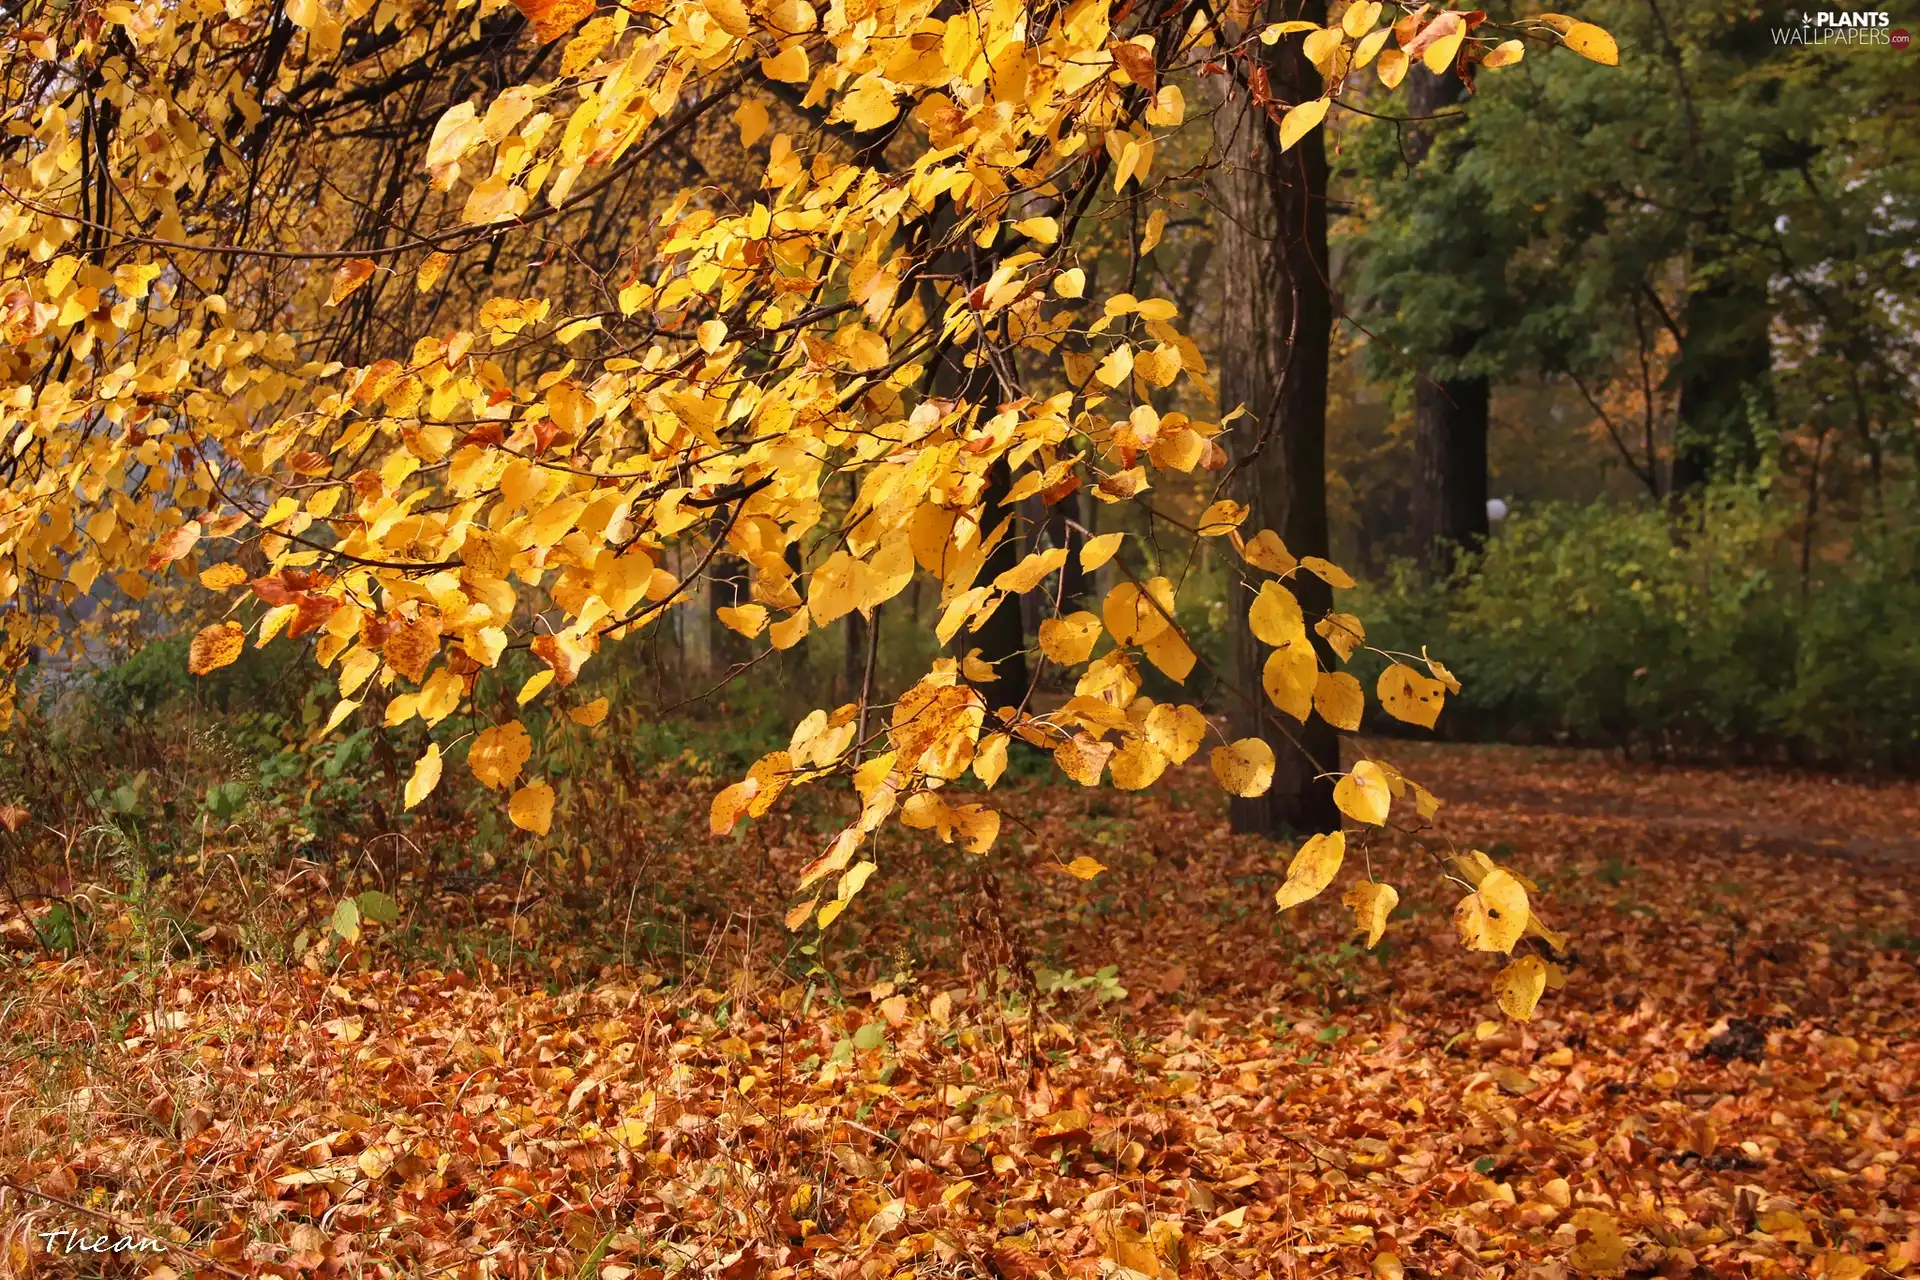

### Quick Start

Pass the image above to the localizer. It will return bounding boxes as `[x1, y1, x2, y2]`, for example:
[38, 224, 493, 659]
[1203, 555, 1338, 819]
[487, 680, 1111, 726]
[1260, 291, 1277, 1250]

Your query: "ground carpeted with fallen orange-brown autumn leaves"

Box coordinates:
[0, 743, 1920, 1280]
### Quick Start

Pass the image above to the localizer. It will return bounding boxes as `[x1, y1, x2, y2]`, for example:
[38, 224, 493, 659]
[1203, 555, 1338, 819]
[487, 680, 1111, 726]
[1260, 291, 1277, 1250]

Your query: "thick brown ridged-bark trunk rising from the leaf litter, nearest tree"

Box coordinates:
[1213, 0, 1340, 835]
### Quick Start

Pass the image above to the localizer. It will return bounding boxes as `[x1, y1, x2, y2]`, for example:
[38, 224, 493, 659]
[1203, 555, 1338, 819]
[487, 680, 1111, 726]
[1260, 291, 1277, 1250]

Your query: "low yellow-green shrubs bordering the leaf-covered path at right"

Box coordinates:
[1359, 486, 1920, 770]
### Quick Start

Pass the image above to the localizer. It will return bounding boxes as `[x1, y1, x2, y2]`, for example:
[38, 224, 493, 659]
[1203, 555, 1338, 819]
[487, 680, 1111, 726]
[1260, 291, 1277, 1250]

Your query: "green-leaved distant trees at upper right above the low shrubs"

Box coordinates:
[1344, 0, 1920, 529]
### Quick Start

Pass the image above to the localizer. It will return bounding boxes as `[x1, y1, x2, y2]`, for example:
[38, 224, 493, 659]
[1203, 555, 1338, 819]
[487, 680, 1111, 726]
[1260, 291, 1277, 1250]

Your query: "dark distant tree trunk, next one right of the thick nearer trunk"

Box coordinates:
[1407, 65, 1492, 574]
